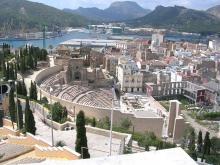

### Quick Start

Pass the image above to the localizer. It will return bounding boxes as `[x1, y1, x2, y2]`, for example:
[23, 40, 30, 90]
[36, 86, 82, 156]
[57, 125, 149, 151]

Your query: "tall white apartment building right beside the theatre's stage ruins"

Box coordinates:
[116, 56, 143, 93]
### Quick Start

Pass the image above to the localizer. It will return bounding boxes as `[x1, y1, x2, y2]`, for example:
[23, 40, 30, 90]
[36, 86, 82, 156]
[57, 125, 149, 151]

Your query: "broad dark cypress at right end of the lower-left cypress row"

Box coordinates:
[25, 98, 36, 135]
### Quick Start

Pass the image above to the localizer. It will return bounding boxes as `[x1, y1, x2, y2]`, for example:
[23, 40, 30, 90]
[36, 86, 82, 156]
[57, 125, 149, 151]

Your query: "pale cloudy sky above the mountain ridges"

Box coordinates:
[30, 0, 220, 10]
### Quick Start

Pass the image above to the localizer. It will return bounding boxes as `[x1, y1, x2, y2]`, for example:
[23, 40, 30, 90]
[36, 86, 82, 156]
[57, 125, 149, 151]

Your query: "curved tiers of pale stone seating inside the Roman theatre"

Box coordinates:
[40, 74, 112, 108]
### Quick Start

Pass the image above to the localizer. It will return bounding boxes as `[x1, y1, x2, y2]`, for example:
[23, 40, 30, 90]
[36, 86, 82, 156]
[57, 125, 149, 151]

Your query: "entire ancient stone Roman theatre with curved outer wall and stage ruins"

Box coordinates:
[35, 46, 183, 140]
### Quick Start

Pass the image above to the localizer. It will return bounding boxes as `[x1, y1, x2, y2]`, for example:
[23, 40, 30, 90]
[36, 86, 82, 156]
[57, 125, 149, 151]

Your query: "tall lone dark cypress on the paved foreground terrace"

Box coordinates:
[75, 111, 90, 159]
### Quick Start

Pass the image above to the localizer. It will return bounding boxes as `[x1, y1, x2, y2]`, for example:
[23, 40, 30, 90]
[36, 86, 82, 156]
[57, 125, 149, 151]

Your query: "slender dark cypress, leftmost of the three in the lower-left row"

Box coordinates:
[8, 88, 16, 128]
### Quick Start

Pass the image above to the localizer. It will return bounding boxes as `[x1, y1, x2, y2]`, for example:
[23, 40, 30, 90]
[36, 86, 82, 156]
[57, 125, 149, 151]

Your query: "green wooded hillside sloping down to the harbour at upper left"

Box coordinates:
[0, 0, 90, 31]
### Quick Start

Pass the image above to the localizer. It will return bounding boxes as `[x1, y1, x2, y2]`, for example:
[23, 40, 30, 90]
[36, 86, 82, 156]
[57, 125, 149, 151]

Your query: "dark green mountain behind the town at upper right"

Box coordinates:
[128, 6, 220, 32]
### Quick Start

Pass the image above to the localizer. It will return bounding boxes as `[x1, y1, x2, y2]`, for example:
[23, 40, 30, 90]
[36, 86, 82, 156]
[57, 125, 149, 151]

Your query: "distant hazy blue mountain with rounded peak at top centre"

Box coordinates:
[64, 1, 150, 21]
